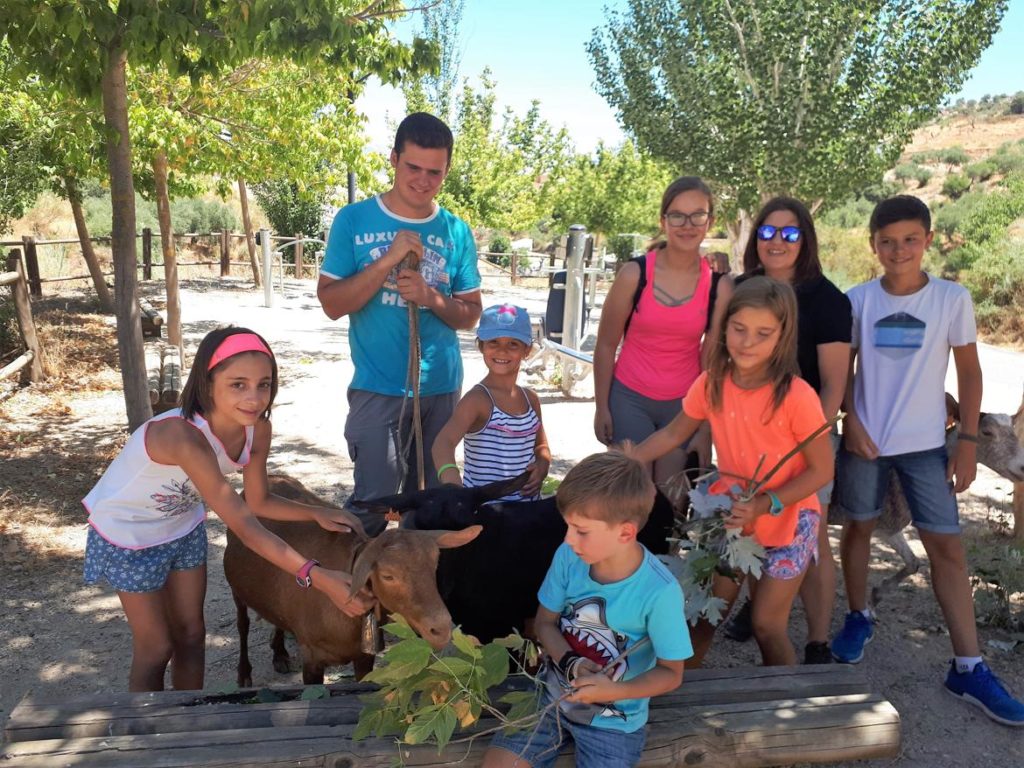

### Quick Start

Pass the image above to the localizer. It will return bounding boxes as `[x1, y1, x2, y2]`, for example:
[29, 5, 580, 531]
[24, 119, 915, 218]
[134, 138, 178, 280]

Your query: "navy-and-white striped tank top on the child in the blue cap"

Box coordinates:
[462, 384, 541, 502]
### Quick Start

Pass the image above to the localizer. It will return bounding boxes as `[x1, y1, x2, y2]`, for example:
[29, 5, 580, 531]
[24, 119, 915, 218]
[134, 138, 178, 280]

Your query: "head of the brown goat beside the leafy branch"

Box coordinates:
[352, 525, 483, 649]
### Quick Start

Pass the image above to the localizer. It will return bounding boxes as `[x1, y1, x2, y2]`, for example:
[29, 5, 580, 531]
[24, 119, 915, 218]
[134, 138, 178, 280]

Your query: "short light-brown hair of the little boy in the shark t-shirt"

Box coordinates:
[555, 451, 654, 529]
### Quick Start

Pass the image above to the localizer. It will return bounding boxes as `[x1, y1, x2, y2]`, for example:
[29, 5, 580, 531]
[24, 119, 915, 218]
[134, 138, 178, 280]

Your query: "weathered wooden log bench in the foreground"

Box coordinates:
[0, 665, 900, 768]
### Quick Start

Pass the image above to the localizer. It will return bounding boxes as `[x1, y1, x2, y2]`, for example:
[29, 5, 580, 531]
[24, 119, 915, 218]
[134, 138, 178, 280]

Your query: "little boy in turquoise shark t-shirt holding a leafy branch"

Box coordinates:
[483, 451, 693, 768]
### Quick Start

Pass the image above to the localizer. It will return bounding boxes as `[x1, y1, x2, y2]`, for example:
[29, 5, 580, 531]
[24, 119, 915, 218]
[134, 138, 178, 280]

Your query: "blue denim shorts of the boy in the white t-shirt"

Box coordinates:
[836, 445, 961, 534]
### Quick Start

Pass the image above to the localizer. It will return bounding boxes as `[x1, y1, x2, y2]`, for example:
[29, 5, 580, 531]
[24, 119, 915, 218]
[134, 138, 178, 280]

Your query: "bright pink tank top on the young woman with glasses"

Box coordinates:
[614, 250, 711, 400]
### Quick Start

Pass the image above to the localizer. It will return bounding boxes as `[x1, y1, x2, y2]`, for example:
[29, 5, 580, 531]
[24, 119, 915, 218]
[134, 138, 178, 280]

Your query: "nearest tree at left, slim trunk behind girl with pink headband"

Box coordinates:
[0, 0, 433, 429]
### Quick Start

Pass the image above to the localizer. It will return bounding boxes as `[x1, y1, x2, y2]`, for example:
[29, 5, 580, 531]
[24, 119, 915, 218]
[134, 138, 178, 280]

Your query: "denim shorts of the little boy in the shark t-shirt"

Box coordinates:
[490, 694, 647, 768]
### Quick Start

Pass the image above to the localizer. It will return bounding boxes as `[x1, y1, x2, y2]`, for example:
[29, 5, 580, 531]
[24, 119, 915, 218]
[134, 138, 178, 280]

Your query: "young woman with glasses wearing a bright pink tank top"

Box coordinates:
[594, 176, 732, 482]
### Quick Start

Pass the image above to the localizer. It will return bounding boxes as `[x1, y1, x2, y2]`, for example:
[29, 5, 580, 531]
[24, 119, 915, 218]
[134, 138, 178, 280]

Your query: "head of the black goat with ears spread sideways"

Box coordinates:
[352, 472, 529, 529]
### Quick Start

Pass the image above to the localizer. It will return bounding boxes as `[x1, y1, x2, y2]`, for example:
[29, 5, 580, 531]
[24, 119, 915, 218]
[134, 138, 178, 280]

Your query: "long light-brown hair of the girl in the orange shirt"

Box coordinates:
[707, 275, 800, 420]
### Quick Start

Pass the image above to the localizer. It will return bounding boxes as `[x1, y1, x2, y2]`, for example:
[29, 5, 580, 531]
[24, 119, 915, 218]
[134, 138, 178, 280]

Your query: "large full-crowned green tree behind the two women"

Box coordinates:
[588, 0, 1007, 256]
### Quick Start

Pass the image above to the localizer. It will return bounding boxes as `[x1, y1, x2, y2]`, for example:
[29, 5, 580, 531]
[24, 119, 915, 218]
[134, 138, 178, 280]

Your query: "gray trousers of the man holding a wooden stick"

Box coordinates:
[345, 389, 459, 536]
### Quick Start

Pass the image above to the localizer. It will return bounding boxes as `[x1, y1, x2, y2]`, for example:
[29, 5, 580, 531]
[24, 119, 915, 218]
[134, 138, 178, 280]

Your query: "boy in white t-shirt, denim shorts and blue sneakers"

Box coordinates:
[831, 195, 1024, 726]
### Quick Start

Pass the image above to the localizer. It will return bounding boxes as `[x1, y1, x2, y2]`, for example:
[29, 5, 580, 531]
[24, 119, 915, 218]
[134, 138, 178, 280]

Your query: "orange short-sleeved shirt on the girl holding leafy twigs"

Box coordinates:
[683, 373, 825, 547]
